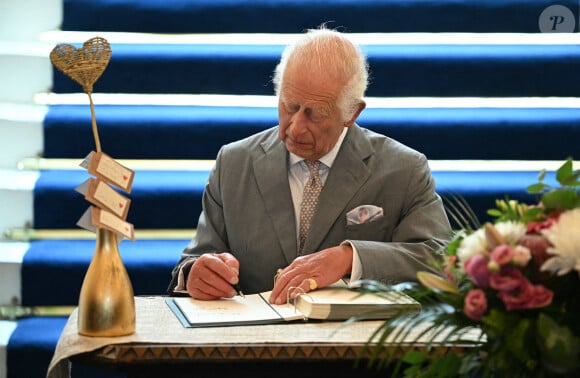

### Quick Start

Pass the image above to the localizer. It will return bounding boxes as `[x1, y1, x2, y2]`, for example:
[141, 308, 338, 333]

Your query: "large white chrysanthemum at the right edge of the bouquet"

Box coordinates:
[541, 208, 580, 275]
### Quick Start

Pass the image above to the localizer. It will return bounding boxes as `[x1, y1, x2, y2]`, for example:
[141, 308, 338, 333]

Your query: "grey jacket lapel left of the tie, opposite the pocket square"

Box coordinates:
[254, 134, 298, 264]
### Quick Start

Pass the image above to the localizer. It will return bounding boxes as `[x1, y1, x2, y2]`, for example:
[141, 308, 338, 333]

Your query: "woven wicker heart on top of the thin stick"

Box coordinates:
[50, 37, 111, 93]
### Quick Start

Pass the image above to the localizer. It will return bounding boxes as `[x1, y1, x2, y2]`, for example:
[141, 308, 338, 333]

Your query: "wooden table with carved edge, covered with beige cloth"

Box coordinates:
[48, 297, 468, 378]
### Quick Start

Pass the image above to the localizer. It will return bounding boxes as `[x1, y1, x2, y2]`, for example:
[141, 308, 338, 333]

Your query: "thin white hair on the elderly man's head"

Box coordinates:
[272, 26, 369, 121]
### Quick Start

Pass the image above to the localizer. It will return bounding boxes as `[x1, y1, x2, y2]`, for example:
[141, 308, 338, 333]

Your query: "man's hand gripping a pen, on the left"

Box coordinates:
[186, 252, 240, 300]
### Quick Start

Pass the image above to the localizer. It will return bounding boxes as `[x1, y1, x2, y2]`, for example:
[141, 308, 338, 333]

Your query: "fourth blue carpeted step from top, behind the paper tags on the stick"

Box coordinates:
[34, 171, 556, 229]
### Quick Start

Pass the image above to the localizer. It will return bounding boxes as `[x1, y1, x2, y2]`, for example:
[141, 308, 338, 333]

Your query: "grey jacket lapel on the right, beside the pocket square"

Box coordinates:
[304, 125, 373, 253]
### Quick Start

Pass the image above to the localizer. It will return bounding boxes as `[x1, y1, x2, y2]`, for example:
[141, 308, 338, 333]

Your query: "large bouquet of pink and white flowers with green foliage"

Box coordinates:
[369, 159, 580, 377]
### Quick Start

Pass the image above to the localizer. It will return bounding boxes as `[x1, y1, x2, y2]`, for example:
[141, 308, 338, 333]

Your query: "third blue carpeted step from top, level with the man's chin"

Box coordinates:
[44, 105, 580, 161]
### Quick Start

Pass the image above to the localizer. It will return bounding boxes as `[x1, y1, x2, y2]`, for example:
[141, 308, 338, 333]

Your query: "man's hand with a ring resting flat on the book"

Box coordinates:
[269, 245, 353, 304]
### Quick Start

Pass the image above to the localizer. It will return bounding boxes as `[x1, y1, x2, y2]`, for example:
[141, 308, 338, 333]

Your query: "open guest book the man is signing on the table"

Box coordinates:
[166, 284, 421, 328]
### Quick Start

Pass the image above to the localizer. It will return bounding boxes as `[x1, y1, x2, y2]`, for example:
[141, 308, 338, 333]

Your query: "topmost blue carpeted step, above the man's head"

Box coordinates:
[62, 0, 578, 33]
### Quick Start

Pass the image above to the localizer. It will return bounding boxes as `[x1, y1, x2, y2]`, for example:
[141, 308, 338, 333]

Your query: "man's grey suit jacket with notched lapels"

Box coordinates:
[168, 125, 450, 294]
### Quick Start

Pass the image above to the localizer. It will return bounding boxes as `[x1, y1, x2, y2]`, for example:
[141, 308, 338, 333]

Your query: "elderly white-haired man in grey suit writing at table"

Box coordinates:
[168, 28, 450, 304]
